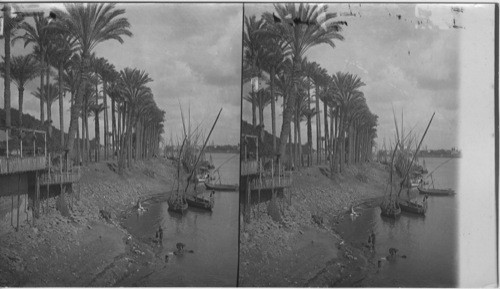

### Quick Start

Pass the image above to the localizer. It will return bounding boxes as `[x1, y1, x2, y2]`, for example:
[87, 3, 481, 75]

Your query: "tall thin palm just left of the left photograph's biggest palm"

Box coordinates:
[12, 15, 51, 122]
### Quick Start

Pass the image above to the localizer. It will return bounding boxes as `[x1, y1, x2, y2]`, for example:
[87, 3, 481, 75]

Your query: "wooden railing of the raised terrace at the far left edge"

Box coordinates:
[0, 156, 47, 175]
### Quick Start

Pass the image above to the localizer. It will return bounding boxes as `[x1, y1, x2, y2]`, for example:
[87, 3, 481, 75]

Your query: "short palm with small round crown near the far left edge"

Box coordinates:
[0, 54, 39, 127]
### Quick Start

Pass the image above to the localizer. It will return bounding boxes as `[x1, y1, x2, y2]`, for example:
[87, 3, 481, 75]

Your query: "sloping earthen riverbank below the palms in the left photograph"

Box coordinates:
[0, 159, 179, 287]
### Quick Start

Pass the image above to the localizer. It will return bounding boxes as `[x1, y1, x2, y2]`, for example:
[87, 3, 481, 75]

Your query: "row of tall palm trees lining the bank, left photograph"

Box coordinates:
[1, 3, 165, 171]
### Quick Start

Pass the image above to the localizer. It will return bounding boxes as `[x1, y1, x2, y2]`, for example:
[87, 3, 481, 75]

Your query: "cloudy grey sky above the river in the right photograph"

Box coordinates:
[242, 4, 470, 149]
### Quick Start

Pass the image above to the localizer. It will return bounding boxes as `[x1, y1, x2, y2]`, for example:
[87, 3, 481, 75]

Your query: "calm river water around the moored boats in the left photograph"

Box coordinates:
[122, 153, 239, 287]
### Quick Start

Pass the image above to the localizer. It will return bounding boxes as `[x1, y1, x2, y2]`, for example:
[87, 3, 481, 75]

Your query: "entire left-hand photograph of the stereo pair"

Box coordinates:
[0, 3, 243, 287]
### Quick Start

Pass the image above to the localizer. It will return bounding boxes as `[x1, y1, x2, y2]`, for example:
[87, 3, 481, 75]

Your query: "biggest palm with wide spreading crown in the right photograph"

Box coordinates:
[262, 3, 344, 159]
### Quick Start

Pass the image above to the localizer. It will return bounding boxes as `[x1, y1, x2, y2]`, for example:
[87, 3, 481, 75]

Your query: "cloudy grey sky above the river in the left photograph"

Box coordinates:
[0, 3, 242, 145]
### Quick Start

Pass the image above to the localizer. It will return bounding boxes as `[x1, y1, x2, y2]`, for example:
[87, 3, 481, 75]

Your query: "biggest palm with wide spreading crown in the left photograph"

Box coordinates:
[56, 3, 132, 159]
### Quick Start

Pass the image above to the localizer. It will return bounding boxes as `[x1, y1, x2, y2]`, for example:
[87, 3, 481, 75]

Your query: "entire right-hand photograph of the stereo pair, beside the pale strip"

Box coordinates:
[238, 3, 494, 287]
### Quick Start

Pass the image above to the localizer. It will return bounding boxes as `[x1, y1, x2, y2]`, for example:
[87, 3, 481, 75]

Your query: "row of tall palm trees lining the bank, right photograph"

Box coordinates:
[243, 3, 377, 172]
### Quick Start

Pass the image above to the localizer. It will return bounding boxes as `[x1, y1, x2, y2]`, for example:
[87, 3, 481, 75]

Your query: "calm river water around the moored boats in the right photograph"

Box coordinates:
[336, 158, 461, 287]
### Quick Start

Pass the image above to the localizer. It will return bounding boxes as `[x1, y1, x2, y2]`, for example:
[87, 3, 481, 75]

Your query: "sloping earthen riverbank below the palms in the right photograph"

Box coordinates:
[239, 163, 398, 287]
